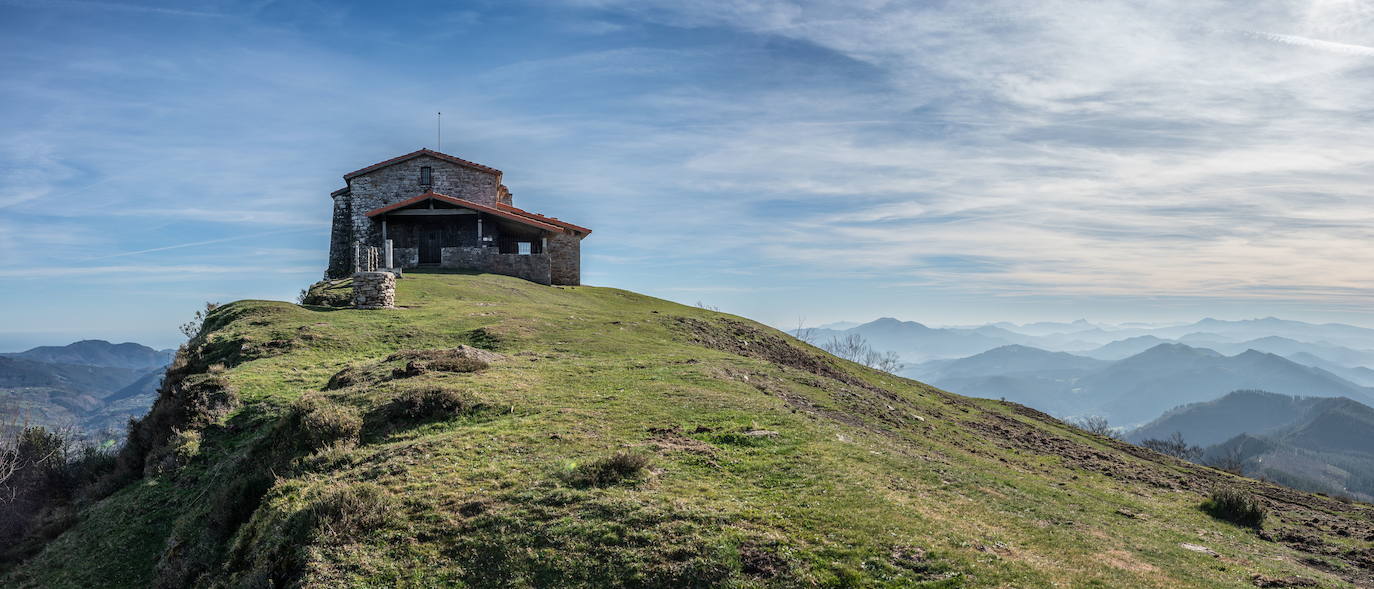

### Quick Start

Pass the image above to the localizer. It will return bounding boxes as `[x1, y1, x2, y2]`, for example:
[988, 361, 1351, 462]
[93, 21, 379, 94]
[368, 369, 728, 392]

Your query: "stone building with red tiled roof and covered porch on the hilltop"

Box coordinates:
[327, 150, 592, 284]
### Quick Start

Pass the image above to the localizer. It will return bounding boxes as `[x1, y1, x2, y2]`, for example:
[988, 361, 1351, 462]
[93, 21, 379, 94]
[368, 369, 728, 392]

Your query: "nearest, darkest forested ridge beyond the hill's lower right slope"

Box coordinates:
[1127, 390, 1374, 501]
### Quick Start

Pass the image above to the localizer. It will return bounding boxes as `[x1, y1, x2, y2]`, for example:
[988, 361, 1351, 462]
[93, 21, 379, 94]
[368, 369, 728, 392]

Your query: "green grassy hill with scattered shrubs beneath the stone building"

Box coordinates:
[0, 273, 1374, 588]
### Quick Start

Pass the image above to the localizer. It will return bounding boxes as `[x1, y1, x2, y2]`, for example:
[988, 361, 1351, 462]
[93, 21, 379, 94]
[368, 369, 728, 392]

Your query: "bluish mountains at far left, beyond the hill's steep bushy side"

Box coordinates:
[0, 339, 174, 437]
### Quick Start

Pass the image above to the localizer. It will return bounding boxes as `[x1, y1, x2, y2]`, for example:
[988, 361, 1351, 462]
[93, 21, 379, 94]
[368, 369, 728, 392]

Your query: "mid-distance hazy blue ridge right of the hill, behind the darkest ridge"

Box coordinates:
[903, 343, 1374, 426]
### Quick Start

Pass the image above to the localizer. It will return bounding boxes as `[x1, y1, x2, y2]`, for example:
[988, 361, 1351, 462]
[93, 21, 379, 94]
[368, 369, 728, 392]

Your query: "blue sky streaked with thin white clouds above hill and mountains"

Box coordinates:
[0, 0, 1374, 350]
